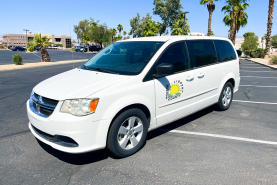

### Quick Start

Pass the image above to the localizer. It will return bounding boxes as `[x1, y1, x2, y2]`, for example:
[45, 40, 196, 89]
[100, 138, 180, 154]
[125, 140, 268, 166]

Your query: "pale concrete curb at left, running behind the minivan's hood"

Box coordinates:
[0, 59, 88, 72]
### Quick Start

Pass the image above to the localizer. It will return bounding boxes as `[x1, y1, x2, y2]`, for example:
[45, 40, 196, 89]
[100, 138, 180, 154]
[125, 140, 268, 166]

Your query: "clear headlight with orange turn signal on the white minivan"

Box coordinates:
[60, 99, 99, 116]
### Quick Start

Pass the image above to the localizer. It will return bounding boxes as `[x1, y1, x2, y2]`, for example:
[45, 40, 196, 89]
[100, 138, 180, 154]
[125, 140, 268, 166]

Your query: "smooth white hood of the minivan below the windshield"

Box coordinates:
[34, 69, 129, 100]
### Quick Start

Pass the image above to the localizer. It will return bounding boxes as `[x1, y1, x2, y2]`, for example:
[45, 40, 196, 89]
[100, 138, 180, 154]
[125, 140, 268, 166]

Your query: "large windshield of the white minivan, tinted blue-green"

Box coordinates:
[82, 41, 164, 75]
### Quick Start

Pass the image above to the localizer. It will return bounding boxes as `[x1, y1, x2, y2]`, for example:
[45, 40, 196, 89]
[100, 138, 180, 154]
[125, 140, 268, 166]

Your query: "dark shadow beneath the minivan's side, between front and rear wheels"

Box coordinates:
[147, 106, 215, 140]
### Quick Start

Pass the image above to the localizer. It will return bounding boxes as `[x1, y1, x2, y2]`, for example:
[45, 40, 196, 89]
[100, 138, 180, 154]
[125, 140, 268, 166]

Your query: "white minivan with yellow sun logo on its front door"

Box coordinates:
[27, 36, 240, 157]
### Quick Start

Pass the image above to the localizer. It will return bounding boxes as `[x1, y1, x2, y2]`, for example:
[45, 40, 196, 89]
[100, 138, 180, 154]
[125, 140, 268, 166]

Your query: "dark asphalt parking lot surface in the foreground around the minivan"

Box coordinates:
[0, 60, 277, 185]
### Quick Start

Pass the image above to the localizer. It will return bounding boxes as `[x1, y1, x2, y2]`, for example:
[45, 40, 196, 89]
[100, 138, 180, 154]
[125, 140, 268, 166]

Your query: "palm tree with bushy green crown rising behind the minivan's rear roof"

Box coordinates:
[221, 0, 250, 45]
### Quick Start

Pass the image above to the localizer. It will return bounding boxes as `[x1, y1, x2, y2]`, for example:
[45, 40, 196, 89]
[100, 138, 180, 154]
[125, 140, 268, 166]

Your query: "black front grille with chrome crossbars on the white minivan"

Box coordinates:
[30, 93, 59, 118]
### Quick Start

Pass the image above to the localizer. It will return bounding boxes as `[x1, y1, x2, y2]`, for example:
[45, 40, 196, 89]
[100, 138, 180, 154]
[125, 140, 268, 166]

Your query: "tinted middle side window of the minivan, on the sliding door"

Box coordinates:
[188, 40, 217, 67]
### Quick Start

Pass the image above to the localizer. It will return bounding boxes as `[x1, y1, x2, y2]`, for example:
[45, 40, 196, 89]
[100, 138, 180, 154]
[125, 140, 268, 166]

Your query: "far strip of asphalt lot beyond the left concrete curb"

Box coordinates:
[0, 49, 95, 65]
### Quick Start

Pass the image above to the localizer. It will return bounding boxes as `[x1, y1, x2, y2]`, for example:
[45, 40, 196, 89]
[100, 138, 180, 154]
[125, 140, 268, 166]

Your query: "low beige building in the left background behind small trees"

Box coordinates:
[2, 33, 71, 48]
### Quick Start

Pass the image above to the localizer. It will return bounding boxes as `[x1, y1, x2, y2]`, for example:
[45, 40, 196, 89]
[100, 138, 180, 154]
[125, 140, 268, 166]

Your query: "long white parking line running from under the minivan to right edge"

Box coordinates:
[157, 129, 277, 145]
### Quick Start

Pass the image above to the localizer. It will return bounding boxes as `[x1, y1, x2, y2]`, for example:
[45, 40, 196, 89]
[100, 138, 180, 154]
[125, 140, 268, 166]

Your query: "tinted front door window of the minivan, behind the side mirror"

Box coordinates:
[157, 42, 190, 72]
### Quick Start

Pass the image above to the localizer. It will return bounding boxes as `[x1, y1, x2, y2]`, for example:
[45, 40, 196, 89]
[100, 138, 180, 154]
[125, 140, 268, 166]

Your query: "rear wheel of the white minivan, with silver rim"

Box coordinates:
[216, 82, 233, 111]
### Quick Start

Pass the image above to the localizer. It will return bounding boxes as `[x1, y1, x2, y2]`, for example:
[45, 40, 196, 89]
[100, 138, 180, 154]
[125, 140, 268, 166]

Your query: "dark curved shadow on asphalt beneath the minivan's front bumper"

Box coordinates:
[37, 139, 109, 165]
